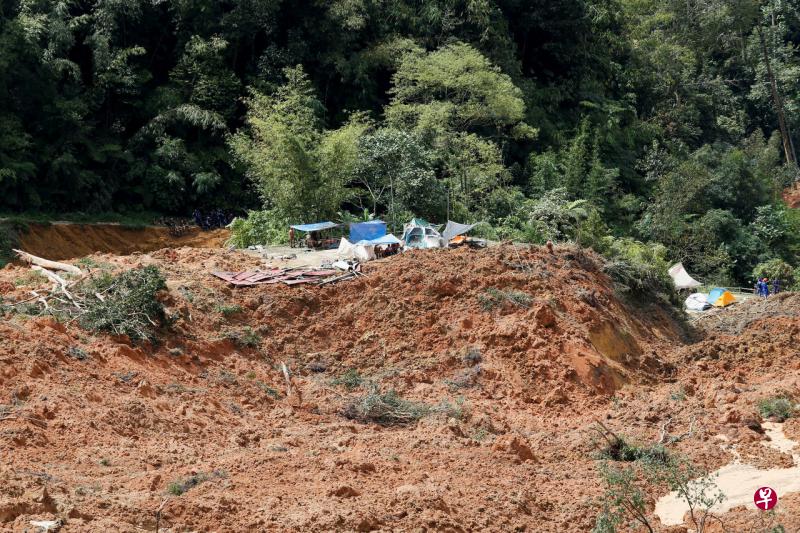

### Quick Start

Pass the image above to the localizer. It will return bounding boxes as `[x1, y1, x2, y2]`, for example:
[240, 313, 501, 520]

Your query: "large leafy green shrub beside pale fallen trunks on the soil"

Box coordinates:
[79, 266, 167, 342]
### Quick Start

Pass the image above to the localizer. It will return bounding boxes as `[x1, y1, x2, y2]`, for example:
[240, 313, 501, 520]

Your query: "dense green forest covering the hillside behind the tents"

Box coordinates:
[0, 0, 800, 283]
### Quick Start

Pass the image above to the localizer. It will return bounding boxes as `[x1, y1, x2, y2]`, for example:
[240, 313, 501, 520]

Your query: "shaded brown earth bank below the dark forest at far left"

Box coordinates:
[19, 223, 229, 260]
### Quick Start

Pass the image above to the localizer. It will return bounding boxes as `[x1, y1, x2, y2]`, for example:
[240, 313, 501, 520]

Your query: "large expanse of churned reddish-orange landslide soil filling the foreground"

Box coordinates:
[0, 245, 800, 532]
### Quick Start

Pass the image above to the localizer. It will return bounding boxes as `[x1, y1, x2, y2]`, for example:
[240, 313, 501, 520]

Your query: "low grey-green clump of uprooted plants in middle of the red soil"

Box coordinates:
[342, 385, 431, 426]
